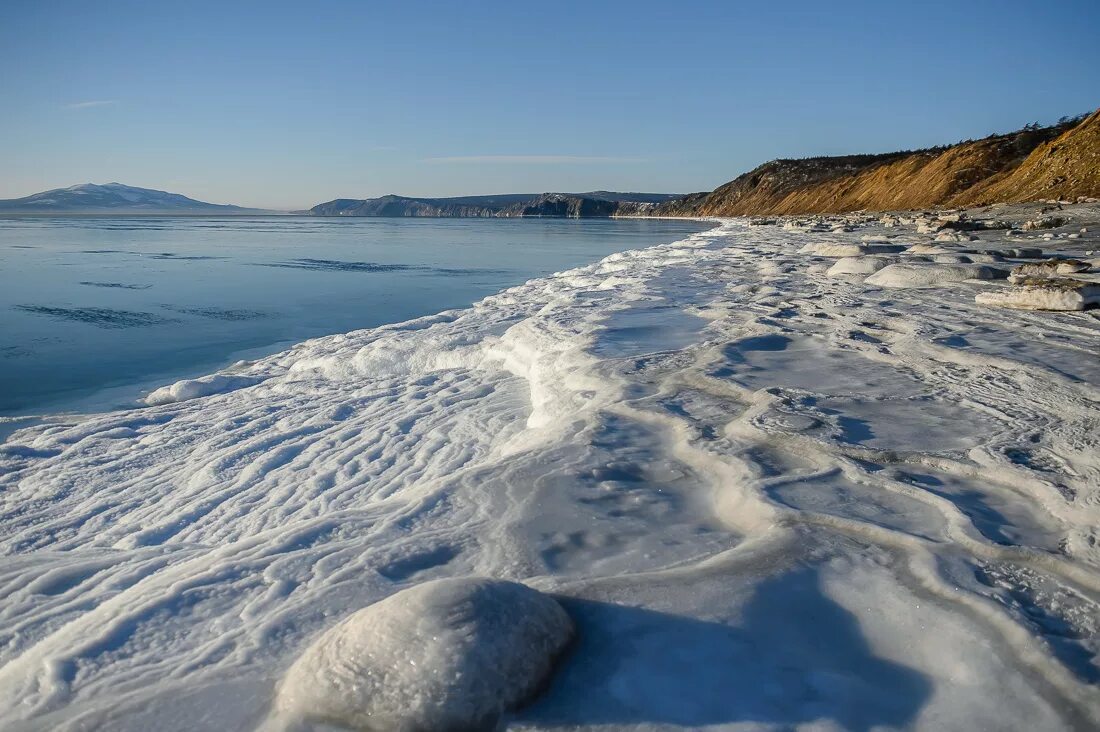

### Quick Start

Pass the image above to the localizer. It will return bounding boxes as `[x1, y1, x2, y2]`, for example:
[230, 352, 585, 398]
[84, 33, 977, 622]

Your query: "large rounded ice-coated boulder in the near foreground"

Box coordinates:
[276, 578, 573, 732]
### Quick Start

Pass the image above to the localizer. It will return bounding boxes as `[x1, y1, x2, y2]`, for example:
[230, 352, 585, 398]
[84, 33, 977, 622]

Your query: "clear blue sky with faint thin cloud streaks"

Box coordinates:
[0, 0, 1100, 208]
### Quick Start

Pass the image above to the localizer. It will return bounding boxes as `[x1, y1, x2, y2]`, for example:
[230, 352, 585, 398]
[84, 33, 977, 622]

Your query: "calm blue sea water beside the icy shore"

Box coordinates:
[0, 217, 707, 416]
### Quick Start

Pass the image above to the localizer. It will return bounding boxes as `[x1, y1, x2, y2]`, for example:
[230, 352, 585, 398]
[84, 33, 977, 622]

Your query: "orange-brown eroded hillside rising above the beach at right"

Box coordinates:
[653, 111, 1100, 216]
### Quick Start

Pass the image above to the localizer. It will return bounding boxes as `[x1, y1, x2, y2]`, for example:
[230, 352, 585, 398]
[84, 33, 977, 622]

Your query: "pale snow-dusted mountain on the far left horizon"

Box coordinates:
[0, 183, 259, 214]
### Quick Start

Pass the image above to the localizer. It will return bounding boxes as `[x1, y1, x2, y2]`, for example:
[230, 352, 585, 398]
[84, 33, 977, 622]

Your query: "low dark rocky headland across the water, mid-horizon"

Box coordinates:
[308, 190, 680, 218]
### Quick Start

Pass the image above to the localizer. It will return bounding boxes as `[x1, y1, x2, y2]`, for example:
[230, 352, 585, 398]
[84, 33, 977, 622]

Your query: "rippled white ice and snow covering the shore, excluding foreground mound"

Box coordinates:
[0, 208, 1100, 730]
